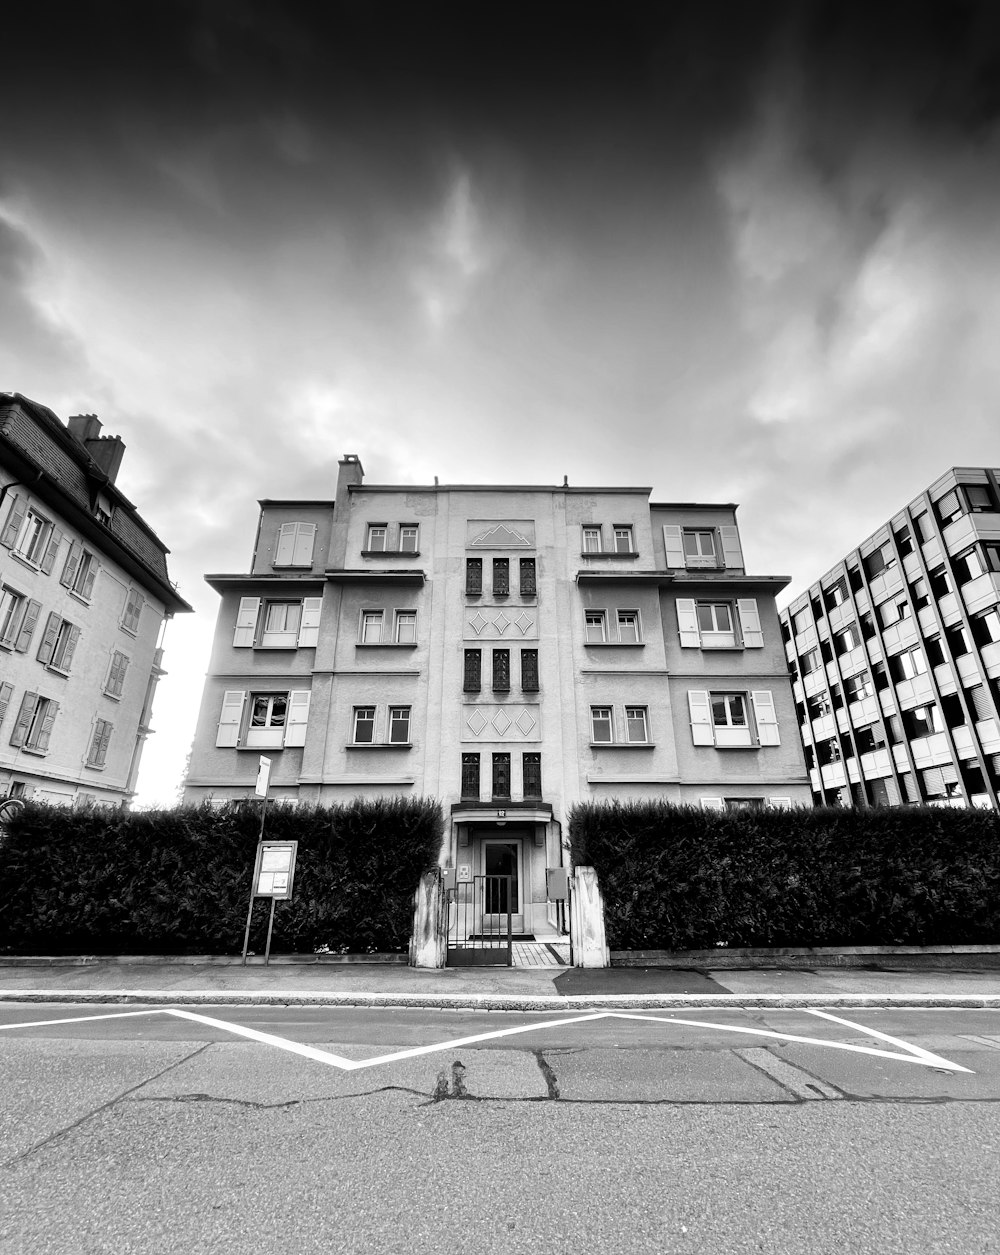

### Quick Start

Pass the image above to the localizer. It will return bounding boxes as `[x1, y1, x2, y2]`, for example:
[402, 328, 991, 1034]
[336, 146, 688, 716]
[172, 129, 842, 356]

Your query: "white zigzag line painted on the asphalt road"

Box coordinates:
[0, 1007, 972, 1076]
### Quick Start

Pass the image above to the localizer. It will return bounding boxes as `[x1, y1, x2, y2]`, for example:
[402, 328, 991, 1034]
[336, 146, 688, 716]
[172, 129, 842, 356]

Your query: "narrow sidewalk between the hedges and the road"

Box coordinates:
[0, 956, 1000, 1010]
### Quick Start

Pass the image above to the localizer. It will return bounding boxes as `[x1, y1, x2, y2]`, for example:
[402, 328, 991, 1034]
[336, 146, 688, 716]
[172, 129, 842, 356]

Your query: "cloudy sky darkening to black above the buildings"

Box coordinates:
[0, 0, 1000, 804]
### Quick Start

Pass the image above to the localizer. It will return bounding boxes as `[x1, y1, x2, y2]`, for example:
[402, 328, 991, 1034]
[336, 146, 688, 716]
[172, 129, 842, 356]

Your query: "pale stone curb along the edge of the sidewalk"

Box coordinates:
[0, 989, 1000, 1012]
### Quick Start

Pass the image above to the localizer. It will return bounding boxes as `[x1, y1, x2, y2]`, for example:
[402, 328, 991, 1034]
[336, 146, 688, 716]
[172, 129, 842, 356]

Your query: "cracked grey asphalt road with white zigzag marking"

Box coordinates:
[0, 1004, 1000, 1255]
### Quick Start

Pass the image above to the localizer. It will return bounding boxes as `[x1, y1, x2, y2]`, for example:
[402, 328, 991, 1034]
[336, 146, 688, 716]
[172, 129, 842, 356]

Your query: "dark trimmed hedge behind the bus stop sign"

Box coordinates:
[0, 798, 444, 954]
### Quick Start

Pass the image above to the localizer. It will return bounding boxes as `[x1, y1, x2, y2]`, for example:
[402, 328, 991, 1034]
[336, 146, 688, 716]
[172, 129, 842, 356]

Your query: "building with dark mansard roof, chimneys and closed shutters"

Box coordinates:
[0, 393, 191, 806]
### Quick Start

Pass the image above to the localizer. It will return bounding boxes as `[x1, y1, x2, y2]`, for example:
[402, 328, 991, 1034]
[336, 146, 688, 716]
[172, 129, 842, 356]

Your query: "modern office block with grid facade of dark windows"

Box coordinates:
[780, 467, 1000, 807]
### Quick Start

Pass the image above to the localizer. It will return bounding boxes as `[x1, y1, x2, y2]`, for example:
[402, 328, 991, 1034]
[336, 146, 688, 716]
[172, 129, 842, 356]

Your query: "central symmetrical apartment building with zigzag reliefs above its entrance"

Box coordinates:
[184, 456, 809, 934]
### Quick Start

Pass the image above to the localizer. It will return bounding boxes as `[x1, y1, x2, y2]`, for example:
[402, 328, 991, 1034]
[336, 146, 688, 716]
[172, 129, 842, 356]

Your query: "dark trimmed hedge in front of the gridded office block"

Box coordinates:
[570, 802, 1000, 950]
